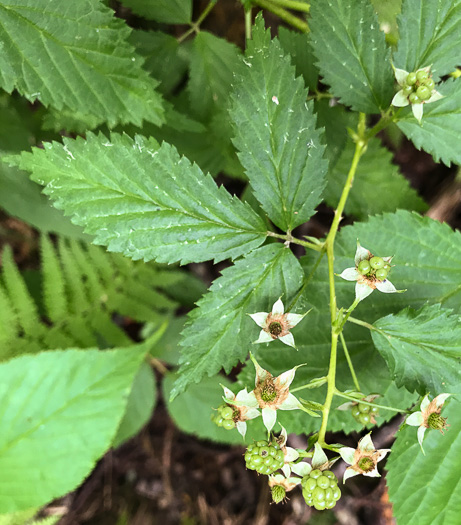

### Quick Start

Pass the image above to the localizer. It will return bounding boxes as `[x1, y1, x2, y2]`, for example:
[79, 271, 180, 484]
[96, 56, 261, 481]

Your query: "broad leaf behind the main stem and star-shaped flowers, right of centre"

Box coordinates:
[242, 211, 461, 439]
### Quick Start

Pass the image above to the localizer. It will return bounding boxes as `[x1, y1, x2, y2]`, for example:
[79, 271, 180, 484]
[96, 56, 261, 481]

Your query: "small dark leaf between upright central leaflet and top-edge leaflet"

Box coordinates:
[278, 26, 319, 91]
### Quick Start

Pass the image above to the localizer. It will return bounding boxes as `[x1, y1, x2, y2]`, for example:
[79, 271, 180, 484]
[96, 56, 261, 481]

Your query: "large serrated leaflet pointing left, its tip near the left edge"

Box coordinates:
[8, 133, 266, 264]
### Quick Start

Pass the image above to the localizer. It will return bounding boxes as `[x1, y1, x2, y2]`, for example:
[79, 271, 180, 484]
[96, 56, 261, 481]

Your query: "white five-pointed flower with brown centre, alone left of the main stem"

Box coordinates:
[249, 299, 309, 348]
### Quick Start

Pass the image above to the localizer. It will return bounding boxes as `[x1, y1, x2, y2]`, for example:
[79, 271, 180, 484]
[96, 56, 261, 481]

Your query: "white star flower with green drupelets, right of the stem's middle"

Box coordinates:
[339, 241, 405, 301]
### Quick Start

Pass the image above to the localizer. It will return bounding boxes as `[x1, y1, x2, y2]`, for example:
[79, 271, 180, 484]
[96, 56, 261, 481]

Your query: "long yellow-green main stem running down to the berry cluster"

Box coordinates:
[318, 113, 367, 446]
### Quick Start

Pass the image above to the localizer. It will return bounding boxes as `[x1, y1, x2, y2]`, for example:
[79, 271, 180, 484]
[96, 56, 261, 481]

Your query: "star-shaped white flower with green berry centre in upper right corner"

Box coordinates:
[391, 66, 443, 123]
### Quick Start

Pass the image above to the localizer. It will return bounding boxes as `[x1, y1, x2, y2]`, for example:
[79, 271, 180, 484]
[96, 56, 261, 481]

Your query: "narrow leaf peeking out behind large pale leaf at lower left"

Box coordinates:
[112, 363, 157, 447]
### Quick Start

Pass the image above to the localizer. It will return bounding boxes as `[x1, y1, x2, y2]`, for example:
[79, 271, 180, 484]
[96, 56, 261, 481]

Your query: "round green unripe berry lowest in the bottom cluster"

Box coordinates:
[301, 469, 341, 510]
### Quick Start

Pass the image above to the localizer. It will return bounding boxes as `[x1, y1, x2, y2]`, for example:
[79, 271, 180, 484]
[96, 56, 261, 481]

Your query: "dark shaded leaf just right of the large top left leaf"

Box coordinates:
[129, 30, 187, 93]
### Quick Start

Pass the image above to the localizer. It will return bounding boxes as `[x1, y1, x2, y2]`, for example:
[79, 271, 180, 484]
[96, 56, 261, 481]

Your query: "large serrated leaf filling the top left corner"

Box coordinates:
[0, 0, 164, 126]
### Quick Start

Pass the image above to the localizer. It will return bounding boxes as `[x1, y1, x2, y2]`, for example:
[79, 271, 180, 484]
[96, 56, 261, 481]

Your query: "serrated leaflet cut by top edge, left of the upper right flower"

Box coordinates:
[311, 0, 395, 113]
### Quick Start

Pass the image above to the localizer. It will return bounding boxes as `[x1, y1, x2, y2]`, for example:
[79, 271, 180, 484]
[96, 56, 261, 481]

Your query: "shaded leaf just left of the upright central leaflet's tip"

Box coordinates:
[187, 31, 240, 121]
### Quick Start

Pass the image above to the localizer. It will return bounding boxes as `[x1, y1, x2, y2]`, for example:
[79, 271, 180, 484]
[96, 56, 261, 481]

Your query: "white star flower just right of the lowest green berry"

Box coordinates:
[339, 434, 390, 483]
